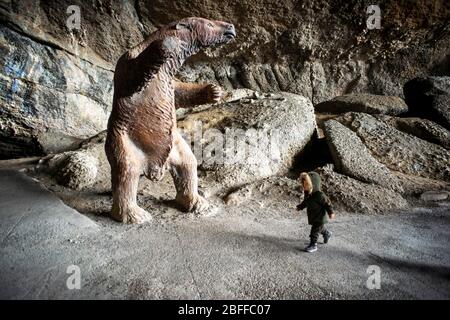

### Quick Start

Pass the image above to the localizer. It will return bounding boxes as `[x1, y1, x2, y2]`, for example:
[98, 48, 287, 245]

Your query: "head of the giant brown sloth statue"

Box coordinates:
[168, 18, 236, 49]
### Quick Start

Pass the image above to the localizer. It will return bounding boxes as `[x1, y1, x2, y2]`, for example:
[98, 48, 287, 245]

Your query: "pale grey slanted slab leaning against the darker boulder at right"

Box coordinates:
[324, 120, 402, 191]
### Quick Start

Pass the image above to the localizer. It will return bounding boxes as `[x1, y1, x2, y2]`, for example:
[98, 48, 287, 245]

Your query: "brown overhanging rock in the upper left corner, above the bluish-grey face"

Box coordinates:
[0, 0, 145, 69]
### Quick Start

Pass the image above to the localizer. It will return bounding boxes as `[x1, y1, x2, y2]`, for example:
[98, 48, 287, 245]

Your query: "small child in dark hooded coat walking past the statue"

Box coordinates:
[297, 172, 334, 252]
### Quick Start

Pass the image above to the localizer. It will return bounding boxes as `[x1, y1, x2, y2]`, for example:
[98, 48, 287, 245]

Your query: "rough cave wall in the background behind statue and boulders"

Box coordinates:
[0, 0, 450, 158]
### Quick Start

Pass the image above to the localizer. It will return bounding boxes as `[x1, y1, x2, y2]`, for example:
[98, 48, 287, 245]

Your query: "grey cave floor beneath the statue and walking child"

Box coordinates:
[0, 170, 450, 299]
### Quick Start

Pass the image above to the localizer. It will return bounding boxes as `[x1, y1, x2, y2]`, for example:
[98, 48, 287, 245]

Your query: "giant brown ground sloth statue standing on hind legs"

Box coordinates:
[105, 18, 236, 223]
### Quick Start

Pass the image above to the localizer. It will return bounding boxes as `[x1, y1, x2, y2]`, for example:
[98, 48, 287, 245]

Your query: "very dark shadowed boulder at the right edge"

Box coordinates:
[403, 77, 450, 129]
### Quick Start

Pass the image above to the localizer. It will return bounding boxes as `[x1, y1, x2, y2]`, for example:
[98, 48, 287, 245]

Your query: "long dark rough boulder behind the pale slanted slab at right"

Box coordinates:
[339, 113, 450, 181]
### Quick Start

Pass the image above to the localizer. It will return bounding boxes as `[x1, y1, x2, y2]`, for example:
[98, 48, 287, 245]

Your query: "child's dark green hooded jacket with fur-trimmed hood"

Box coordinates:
[297, 172, 333, 225]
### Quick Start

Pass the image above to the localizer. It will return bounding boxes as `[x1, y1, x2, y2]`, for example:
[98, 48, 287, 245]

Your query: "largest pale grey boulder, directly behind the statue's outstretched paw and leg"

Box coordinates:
[178, 91, 316, 186]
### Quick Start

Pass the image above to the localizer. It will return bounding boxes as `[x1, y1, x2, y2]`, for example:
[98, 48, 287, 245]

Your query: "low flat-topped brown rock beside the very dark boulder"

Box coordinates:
[314, 94, 408, 115]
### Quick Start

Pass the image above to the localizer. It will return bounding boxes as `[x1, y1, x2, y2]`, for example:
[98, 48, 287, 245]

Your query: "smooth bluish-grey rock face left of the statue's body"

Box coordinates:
[0, 26, 113, 158]
